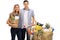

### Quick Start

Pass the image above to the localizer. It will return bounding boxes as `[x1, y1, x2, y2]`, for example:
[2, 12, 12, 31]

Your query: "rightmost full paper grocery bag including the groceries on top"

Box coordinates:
[43, 24, 53, 40]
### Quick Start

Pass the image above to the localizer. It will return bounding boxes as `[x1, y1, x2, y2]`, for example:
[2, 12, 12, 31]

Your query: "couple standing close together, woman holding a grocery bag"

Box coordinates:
[7, 1, 35, 40]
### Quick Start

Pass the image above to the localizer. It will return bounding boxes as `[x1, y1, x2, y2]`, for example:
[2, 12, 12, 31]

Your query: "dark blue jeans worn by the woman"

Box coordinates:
[11, 28, 22, 40]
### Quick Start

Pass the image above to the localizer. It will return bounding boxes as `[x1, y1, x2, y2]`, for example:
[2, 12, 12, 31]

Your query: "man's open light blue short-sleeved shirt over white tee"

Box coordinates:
[18, 9, 34, 28]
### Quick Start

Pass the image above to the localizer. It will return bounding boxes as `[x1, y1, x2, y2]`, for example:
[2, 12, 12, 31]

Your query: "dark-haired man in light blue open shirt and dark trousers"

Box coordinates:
[19, 0, 35, 40]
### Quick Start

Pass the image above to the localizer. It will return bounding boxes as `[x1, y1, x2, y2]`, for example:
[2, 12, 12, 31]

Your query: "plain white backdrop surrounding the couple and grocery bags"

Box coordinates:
[0, 0, 60, 40]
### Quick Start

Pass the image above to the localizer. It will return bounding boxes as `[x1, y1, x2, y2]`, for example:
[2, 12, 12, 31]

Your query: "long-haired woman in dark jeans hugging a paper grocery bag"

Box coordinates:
[7, 4, 21, 40]
